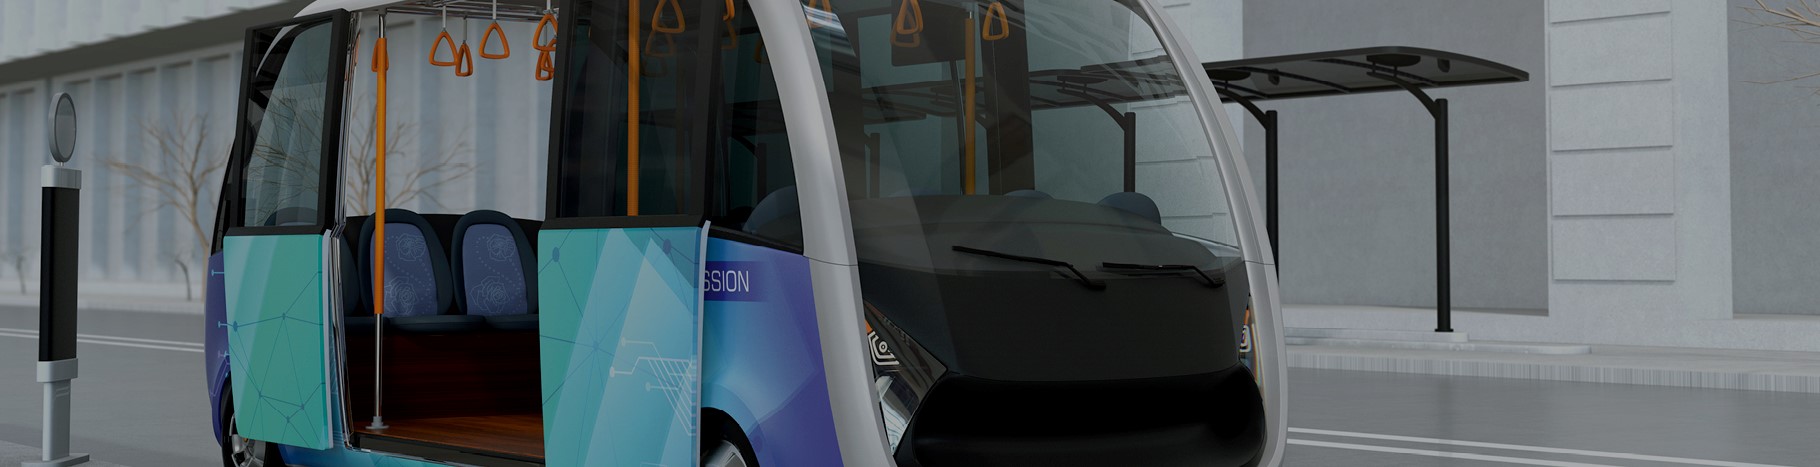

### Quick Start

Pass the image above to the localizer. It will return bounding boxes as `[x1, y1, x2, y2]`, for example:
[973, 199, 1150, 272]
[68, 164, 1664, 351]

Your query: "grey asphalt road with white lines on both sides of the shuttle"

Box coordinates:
[0, 301, 1820, 467]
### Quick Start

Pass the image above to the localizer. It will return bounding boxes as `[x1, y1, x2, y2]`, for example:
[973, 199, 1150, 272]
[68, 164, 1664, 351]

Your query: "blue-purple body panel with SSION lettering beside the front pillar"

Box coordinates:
[703, 238, 844, 465]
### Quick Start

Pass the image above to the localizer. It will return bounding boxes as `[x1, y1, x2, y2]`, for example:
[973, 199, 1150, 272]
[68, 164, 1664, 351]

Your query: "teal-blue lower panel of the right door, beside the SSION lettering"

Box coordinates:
[537, 227, 703, 467]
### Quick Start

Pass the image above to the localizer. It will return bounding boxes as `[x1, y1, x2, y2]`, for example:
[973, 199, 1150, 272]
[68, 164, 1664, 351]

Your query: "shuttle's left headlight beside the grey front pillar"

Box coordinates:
[866, 303, 948, 452]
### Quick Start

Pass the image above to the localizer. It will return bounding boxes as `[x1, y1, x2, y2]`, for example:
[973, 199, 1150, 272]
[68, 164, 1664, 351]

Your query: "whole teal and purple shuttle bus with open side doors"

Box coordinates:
[207, 0, 1285, 467]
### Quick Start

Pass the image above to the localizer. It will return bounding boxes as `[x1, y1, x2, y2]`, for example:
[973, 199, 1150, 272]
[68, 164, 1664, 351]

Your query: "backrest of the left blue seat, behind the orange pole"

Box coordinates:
[359, 209, 453, 316]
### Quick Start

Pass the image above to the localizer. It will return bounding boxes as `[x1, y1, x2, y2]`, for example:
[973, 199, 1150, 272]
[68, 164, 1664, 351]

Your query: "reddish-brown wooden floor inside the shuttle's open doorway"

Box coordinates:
[355, 414, 544, 460]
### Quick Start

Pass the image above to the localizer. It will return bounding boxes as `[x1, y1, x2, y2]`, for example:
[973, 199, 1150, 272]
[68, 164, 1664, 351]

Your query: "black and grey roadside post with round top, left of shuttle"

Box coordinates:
[22, 94, 89, 467]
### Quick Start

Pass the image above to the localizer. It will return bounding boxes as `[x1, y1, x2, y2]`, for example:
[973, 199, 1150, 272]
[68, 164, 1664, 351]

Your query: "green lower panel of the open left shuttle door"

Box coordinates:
[222, 234, 329, 449]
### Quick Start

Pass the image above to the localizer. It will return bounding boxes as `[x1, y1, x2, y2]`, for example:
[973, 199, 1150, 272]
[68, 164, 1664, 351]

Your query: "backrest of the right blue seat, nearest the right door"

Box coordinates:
[450, 211, 537, 316]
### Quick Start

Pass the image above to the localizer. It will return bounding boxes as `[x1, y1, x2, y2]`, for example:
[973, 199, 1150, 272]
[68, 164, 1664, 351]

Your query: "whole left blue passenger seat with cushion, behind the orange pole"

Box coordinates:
[355, 209, 484, 333]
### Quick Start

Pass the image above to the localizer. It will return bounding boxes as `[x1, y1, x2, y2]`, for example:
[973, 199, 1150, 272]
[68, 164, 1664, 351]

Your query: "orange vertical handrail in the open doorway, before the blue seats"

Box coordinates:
[368, 11, 391, 429]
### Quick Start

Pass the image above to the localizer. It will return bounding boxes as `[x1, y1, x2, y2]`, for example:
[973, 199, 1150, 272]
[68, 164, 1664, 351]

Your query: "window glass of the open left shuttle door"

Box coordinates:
[240, 22, 339, 227]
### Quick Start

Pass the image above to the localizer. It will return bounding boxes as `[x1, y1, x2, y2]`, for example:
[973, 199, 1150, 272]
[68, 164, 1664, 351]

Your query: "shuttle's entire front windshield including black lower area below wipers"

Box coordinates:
[804, 0, 1245, 382]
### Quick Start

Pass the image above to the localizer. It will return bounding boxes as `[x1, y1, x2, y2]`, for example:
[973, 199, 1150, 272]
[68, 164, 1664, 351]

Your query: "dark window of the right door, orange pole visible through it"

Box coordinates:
[550, 2, 708, 218]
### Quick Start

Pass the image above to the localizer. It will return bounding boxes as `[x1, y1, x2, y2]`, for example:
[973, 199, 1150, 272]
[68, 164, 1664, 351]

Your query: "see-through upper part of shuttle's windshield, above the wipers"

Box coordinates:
[808, 0, 1238, 272]
